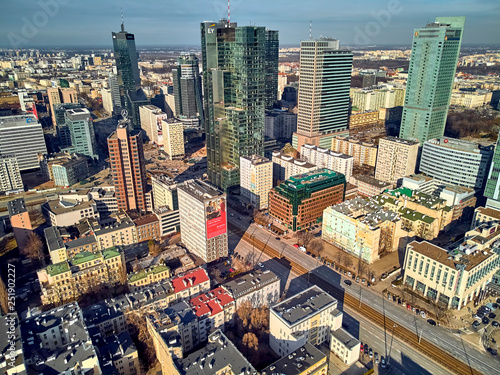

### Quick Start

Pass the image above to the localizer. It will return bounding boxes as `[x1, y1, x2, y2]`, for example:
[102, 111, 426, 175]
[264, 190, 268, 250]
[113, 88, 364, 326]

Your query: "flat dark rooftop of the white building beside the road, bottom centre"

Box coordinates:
[271, 285, 337, 326]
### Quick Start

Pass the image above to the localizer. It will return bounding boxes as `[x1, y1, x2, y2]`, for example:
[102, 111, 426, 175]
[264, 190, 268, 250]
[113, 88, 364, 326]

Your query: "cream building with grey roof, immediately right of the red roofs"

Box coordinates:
[222, 269, 281, 310]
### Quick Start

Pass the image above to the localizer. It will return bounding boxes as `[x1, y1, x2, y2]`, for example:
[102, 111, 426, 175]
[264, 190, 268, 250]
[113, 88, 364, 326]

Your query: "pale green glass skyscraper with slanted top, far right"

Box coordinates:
[399, 17, 465, 143]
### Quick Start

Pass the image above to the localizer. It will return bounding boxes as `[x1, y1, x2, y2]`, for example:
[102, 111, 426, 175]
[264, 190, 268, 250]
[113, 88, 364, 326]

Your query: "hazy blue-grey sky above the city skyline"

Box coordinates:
[0, 0, 500, 48]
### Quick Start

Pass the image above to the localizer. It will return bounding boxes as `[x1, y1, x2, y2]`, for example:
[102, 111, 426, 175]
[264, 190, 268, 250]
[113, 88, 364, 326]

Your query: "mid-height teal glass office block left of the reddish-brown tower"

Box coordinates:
[65, 108, 99, 159]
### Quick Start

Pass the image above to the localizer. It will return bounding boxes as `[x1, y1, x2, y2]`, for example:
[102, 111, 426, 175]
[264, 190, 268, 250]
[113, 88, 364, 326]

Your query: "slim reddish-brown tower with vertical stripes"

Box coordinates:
[108, 120, 147, 211]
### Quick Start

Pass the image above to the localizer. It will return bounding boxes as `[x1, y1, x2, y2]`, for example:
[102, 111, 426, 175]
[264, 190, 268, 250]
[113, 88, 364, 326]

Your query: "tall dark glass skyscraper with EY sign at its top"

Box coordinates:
[201, 20, 277, 191]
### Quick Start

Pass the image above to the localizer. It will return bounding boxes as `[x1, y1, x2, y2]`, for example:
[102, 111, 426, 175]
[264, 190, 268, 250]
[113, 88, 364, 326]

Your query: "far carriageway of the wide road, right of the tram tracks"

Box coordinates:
[228, 209, 500, 374]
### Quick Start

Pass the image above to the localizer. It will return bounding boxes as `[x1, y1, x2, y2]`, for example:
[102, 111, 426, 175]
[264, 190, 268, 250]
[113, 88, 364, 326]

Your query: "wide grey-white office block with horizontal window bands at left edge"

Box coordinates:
[0, 114, 47, 172]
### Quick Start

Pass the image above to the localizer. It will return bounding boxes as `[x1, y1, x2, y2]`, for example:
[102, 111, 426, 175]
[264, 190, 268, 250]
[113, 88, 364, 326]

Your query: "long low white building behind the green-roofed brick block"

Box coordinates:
[300, 143, 354, 181]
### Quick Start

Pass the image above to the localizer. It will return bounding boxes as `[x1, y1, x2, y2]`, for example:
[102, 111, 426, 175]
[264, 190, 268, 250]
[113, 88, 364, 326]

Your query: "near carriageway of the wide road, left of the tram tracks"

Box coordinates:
[229, 230, 452, 375]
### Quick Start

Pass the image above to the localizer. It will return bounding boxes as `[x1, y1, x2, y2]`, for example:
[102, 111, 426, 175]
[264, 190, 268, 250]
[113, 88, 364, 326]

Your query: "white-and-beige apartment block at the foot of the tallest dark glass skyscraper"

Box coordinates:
[240, 155, 273, 210]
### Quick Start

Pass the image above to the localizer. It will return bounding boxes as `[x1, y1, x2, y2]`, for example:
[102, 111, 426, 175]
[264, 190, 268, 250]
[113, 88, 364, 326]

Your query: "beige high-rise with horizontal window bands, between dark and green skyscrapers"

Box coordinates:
[293, 38, 352, 150]
